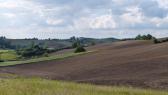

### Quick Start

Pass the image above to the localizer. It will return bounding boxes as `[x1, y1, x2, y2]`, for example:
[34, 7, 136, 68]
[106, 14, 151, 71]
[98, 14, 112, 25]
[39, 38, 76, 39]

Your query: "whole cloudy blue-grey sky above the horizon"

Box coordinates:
[0, 0, 168, 39]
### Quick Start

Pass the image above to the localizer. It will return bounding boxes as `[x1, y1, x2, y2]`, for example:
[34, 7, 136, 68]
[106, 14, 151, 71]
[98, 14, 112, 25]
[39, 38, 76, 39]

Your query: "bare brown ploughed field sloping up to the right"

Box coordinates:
[0, 41, 168, 89]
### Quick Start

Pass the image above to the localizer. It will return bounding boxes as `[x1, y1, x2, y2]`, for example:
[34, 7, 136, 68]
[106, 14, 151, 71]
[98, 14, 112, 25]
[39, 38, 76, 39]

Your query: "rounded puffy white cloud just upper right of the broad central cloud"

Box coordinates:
[120, 6, 144, 25]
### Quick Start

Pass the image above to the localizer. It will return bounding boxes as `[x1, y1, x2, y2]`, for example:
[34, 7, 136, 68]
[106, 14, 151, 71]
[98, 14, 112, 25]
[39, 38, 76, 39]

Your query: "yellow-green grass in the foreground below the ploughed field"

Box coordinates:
[0, 78, 168, 95]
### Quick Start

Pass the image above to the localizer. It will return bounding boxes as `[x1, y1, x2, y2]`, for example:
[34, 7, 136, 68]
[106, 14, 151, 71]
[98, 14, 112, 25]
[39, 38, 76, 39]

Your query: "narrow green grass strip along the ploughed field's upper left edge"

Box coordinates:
[0, 52, 90, 66]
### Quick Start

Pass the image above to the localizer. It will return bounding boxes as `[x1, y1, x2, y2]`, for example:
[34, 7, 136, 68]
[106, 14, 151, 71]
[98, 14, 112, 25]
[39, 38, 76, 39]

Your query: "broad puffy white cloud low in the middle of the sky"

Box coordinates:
[74, 14, 117, 29]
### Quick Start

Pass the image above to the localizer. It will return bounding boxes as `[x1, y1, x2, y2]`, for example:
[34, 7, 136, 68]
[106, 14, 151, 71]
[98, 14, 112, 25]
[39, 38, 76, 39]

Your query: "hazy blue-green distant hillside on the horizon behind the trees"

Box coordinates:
[8, 37, 118, 49]
